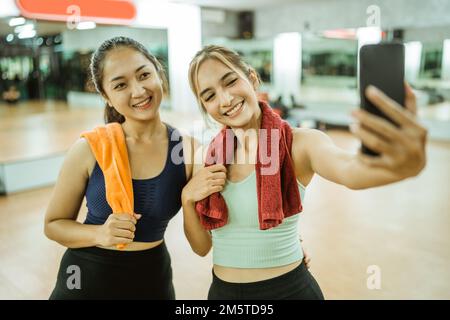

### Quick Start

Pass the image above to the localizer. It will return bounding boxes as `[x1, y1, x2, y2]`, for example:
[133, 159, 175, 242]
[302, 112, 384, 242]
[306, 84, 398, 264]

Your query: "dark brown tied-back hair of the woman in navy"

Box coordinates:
[89, 37, 169, 123]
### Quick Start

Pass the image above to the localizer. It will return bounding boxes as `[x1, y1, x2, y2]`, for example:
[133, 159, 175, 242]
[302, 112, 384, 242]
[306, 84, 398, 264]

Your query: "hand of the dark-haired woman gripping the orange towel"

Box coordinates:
[96, 213, 141, 247]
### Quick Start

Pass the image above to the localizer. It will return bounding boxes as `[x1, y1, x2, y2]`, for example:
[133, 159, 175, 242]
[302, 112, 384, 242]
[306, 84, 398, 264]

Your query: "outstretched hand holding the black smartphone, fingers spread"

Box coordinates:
[352, 83, 427, 180]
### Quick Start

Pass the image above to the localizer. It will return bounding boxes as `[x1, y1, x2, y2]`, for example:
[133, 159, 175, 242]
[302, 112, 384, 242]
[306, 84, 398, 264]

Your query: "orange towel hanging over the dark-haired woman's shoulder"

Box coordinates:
[81, 123, 134, 249]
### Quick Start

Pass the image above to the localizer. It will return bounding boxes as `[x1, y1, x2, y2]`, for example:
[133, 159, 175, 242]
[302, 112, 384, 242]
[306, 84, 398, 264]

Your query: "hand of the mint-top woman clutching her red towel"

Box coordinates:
[181, 164, 227, 203]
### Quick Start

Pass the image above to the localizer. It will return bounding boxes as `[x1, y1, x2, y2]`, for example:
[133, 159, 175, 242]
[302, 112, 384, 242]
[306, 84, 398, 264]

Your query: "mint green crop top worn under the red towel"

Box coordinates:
[212, 171, 305, 268]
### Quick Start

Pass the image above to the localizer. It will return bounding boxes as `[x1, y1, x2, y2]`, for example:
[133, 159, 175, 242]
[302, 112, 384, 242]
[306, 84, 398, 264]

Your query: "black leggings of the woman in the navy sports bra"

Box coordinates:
[50, 242, 175, 300]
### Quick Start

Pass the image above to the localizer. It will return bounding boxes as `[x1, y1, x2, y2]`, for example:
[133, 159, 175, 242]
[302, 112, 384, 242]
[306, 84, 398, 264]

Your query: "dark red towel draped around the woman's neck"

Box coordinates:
[195, 101, 302, 230]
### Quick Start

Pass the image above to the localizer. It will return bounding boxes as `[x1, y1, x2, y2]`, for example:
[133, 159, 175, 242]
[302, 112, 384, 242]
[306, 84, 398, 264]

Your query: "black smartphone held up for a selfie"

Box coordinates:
[359, 42, 405, 156]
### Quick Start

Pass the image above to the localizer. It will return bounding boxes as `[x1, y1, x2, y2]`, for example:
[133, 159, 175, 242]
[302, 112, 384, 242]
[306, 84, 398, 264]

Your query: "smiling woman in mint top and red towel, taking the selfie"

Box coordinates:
[182, 46, 427, 299]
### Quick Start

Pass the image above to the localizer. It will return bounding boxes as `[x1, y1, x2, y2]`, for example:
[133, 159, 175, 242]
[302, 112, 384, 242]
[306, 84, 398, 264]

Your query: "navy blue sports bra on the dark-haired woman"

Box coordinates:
[84, 124, 186, 242]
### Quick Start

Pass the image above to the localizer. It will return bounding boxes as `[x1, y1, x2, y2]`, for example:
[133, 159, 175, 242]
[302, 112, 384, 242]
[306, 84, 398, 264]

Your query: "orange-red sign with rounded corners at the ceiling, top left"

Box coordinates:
[16, 0, 136, 24]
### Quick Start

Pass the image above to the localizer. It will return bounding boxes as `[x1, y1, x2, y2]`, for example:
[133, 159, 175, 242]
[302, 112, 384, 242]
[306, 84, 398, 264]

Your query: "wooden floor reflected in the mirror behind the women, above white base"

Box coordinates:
[0, 101, 202, 163]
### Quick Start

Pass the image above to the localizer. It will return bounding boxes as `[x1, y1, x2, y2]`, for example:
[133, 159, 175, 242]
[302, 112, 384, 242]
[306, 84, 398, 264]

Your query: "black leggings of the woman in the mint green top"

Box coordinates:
[208, 262, 324, 300]
